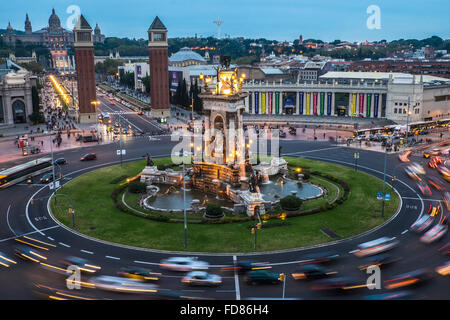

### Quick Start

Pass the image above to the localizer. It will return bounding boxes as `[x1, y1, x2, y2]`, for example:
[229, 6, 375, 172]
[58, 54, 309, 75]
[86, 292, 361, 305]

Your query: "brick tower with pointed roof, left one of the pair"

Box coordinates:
[73, 15, 97, 123]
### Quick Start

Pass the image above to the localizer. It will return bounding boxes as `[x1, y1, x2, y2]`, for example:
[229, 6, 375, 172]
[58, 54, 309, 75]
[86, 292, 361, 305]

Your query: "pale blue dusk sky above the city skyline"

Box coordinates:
[0, 0, 450, 41]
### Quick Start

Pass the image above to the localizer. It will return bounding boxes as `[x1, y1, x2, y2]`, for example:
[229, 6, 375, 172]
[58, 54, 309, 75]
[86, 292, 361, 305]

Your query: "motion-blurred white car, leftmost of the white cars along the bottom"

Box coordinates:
[89, 276, 158, 293]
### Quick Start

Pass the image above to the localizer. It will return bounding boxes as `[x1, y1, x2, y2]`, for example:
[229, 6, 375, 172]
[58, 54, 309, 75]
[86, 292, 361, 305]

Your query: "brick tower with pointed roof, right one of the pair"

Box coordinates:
[148, 17, 170, 118]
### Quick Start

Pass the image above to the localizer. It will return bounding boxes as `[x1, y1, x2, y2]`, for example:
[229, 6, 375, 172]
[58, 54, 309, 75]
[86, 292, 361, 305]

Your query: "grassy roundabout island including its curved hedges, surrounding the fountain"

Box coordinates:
[49, 157, 400, 254]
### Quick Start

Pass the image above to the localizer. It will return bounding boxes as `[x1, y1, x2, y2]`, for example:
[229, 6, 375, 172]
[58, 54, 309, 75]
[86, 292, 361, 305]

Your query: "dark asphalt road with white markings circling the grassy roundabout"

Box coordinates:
[0, 112, 450, 300]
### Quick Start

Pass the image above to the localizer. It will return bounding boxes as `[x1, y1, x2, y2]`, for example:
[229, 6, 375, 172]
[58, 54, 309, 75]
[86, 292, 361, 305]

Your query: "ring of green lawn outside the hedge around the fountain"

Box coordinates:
[51, 157, 399, 253]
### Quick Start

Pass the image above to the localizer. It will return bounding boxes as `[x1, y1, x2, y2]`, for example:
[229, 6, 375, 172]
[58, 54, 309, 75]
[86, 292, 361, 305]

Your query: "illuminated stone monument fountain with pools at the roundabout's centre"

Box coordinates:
[141, 57, 322, 216]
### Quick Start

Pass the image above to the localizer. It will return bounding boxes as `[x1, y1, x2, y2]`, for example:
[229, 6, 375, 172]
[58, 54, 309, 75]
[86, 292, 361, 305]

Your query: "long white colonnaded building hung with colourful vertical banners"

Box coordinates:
[243, 72, 450, 124]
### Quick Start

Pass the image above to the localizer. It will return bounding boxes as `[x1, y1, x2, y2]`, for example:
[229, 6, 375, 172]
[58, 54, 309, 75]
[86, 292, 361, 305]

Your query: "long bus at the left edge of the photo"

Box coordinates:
[0, 158, 52, 189]
